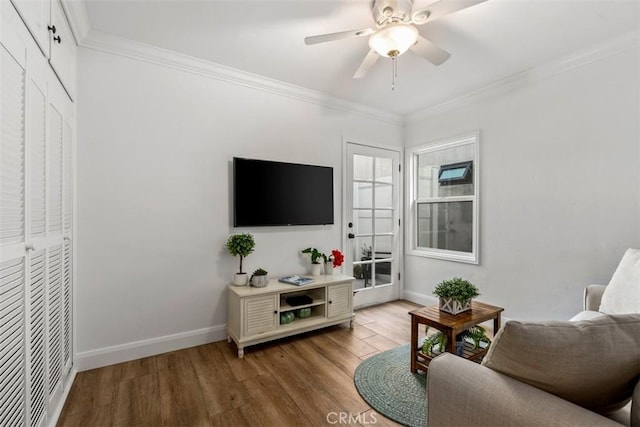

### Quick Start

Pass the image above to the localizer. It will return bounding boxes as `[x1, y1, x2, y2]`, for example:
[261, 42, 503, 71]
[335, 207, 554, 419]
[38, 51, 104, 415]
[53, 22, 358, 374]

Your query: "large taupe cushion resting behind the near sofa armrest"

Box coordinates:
[482, 314, 640, 414]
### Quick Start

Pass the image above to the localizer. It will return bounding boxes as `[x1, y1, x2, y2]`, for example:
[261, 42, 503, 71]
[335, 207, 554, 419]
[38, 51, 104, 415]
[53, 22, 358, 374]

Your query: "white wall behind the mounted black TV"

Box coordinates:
[75, 49, 402, 369]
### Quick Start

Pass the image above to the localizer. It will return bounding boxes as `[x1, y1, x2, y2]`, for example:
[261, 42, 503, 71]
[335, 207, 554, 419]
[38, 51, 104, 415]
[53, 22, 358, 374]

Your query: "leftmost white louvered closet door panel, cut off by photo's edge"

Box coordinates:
[0, 24, 26, 426]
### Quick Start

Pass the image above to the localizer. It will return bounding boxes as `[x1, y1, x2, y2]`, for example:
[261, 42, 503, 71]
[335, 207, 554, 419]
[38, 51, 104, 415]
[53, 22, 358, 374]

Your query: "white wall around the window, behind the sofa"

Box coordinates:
[405, 48, 640, 319]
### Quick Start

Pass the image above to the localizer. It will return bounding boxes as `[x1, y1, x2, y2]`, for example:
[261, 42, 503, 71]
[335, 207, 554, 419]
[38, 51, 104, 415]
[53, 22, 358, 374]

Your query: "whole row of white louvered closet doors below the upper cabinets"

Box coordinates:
[0, 1, 73, 427]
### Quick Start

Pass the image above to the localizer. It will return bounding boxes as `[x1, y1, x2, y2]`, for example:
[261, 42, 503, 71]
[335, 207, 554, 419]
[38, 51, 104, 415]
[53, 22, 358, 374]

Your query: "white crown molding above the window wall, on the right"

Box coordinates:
[405, 31, 640, 124]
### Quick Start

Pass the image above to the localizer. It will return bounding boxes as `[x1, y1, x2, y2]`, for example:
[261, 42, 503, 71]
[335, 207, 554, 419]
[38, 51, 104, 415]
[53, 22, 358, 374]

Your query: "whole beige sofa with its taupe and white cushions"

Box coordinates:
[427, 248, 640, 427]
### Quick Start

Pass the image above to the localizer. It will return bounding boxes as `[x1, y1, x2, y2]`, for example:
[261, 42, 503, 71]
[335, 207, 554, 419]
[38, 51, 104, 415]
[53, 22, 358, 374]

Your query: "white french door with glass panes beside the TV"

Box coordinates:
[343, 142, 401, 307]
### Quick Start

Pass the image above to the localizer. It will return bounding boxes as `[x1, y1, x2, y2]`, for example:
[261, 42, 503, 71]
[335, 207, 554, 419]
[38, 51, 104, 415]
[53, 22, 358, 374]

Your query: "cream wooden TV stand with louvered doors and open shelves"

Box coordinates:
[227, 275, 355, 358]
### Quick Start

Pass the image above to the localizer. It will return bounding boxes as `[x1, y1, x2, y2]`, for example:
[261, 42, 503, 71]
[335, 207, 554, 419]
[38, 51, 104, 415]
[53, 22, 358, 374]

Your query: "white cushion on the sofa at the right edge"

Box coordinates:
[600, 249, 640, 314]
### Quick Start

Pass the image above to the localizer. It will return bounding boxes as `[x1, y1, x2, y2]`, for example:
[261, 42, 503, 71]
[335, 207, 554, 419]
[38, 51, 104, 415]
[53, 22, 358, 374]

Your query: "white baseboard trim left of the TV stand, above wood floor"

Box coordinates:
[74, 325, 227, 372]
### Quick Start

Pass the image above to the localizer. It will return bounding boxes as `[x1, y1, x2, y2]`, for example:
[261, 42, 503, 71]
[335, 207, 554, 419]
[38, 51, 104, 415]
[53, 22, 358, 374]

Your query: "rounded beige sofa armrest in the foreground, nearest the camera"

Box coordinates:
[427, 353, 620, 427]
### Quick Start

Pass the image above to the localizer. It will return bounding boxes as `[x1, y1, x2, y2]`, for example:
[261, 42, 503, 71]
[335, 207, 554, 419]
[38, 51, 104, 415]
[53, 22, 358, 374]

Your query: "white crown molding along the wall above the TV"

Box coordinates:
[80, 30, 404, 127]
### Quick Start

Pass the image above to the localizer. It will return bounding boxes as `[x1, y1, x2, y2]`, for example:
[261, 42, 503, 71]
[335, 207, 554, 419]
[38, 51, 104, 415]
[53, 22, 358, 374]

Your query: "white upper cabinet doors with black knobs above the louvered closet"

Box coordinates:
[11, 0, 77, 100]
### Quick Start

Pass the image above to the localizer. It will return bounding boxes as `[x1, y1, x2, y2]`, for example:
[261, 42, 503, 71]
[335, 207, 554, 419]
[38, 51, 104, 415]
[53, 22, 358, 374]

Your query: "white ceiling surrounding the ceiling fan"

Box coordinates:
[85, 0, 640, 114]
